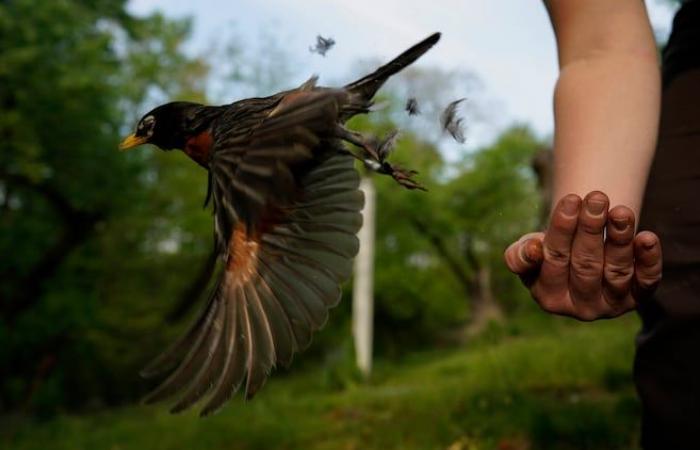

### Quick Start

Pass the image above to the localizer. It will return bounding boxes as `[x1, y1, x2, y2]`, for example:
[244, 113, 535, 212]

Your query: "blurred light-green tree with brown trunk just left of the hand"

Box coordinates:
[444, 126, 542, 334]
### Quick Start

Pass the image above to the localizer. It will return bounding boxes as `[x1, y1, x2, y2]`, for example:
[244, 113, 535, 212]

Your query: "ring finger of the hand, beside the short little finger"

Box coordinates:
[603, 206, 635, 314]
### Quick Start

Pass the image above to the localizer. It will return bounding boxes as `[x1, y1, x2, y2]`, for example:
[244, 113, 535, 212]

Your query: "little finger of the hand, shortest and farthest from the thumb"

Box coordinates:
[632, 231, 663, 301]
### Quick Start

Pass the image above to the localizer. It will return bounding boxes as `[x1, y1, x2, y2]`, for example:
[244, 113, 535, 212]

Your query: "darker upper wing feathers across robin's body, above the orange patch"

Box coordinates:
[209, 89, 347, 255]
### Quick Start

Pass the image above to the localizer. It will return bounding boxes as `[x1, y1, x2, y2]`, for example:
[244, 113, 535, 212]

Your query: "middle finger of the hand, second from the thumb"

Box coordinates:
[569, 191, 608, 310]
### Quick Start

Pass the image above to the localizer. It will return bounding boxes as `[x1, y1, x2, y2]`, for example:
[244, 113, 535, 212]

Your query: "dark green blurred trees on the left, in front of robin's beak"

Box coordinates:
[0, 0, 208, 411]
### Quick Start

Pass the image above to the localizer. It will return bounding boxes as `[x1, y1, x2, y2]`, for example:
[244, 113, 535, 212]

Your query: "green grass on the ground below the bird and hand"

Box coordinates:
[0, 315, 639, 450]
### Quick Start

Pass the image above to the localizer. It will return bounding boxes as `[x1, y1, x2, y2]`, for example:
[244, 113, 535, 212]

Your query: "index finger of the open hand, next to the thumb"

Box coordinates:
[532, 194, 581, 314]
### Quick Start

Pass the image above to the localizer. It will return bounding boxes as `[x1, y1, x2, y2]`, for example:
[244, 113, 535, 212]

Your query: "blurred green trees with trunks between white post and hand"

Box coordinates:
[370, 123, 542, 342]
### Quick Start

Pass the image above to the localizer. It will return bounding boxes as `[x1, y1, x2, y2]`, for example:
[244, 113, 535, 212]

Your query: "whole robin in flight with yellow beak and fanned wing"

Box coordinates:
[120, 33, 440, 416]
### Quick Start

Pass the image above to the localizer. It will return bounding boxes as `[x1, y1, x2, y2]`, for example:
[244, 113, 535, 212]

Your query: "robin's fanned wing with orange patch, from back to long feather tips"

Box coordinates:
[142, 89, 364, 415]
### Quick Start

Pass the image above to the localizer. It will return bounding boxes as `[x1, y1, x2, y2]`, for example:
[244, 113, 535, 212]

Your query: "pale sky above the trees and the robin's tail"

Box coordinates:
[129, 0, 672, 151]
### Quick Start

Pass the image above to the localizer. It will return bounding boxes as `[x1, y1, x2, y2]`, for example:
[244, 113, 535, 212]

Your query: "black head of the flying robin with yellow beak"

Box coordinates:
[119, 102, 202, 150]
